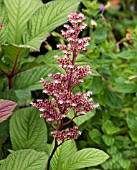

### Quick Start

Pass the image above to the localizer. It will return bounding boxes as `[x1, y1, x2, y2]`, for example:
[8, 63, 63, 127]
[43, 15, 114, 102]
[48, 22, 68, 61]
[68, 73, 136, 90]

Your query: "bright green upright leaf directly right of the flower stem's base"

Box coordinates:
[51, 140, 77, 170]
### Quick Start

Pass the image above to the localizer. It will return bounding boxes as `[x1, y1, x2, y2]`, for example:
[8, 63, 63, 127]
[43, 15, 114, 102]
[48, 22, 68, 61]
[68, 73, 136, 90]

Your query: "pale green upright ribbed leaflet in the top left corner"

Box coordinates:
[4, 0, 42, 44]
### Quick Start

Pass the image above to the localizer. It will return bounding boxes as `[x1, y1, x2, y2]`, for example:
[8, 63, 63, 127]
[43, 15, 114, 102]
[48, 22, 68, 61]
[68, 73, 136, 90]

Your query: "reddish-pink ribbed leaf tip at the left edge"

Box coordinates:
[0, 99, 17, 122]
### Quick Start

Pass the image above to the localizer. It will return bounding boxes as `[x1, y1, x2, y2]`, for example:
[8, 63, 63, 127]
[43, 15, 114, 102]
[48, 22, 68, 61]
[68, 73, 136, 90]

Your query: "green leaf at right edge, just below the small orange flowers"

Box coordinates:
[118, 50, 137, 59]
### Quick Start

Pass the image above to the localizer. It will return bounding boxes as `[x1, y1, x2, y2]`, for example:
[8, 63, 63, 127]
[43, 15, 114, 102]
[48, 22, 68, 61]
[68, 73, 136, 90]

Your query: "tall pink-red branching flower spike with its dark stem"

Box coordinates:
[31, 13, 98, 170]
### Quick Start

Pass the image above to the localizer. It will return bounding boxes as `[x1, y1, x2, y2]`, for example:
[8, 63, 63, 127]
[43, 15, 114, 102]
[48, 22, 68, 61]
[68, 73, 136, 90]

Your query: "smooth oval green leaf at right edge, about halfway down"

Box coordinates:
[113, 83, 137, 93]
